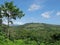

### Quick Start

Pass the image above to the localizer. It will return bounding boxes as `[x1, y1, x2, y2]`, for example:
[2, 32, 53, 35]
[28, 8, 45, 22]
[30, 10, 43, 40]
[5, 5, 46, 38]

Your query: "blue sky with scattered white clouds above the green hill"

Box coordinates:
[0, 0, 60, 25]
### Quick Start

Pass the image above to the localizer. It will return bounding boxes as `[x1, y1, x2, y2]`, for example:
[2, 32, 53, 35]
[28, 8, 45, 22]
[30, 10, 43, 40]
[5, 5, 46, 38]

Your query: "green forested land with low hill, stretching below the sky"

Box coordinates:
[0, 23, 60, 45]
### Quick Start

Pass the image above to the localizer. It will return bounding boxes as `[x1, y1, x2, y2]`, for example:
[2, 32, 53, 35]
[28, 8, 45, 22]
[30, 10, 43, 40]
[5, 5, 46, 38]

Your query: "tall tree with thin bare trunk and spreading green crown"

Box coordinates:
[0, 2, 24, 38]
